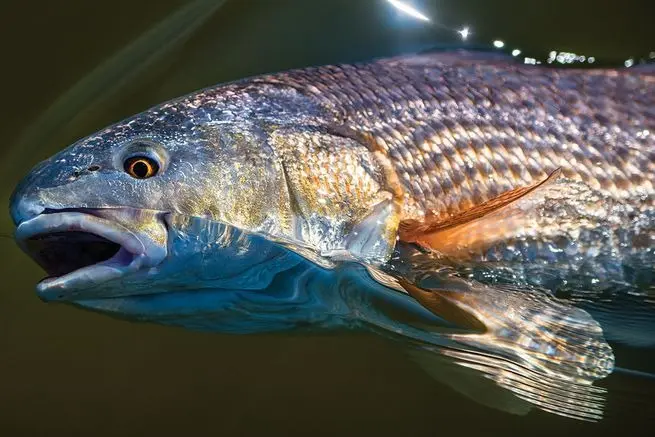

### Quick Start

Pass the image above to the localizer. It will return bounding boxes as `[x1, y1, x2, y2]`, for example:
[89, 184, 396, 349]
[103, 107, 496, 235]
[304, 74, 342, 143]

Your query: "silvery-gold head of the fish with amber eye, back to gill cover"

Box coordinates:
[10, 84, 400, 300]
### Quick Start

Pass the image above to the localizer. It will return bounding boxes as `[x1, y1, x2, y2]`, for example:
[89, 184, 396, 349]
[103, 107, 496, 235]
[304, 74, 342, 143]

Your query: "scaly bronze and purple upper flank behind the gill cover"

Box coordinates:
[254, 54, 655, 219]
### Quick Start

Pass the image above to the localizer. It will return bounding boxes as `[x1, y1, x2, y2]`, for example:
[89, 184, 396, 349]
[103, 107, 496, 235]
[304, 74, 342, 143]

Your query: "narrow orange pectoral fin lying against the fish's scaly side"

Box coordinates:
[399, 169, 561, 258]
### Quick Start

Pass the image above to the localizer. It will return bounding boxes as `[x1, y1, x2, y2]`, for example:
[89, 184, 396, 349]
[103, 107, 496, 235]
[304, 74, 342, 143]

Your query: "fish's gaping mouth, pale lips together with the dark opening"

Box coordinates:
[15, 209, 167, 301]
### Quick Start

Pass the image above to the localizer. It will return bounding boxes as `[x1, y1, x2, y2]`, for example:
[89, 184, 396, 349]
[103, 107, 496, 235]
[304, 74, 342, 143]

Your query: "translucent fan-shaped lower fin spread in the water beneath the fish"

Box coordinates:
[400, 278, 614, 420]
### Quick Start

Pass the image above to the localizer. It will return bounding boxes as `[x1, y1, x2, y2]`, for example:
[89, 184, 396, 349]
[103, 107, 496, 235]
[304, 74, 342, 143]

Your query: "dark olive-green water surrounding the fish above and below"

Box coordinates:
[0, 0, 655, 436]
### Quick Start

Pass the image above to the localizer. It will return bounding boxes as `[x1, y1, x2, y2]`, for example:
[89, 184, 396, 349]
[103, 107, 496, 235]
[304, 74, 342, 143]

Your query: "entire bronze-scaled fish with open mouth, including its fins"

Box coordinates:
[11, 53, 655, 419]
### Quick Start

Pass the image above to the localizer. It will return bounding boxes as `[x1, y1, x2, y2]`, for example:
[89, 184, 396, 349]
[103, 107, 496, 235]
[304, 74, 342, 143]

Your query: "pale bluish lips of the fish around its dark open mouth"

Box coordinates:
[14, 209, 168, 301]
